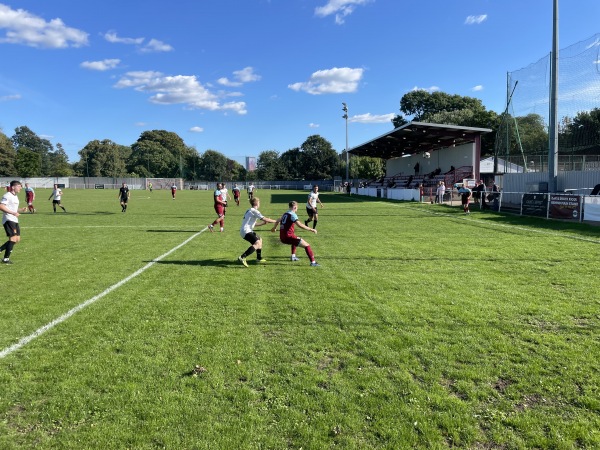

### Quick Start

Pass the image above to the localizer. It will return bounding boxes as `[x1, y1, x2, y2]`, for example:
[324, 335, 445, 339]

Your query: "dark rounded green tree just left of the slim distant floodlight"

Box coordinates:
[300, 135, 338, 180]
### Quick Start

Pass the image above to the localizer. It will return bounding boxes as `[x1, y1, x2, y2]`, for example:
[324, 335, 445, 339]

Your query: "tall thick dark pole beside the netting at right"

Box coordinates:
[548, 0, 558, 192]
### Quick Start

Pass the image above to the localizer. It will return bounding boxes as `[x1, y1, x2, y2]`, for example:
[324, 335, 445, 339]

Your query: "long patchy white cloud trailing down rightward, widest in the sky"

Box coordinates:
[114, 71, 247, 114]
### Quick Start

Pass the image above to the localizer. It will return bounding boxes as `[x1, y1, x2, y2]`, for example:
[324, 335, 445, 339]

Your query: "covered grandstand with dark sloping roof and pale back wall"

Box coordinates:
[348, 122, 492, 185]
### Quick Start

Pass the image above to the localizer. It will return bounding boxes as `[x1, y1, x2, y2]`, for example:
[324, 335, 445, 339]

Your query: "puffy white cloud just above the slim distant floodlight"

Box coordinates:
[288, 67, 364, 95]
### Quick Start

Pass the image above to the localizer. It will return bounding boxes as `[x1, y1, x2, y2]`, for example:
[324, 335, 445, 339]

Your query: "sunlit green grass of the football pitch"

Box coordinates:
[0, 190, 600, 449]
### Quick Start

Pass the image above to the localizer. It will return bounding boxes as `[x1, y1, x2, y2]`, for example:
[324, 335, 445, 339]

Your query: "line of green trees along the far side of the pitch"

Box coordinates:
[0, 91, 600, 181]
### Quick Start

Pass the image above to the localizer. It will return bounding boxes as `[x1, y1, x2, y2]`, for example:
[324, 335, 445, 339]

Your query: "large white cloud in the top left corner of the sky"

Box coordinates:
[0, 3, 88, 48]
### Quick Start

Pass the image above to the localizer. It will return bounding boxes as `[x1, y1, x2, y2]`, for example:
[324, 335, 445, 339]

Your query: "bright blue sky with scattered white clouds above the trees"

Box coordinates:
[0, 0, 600, 164]
